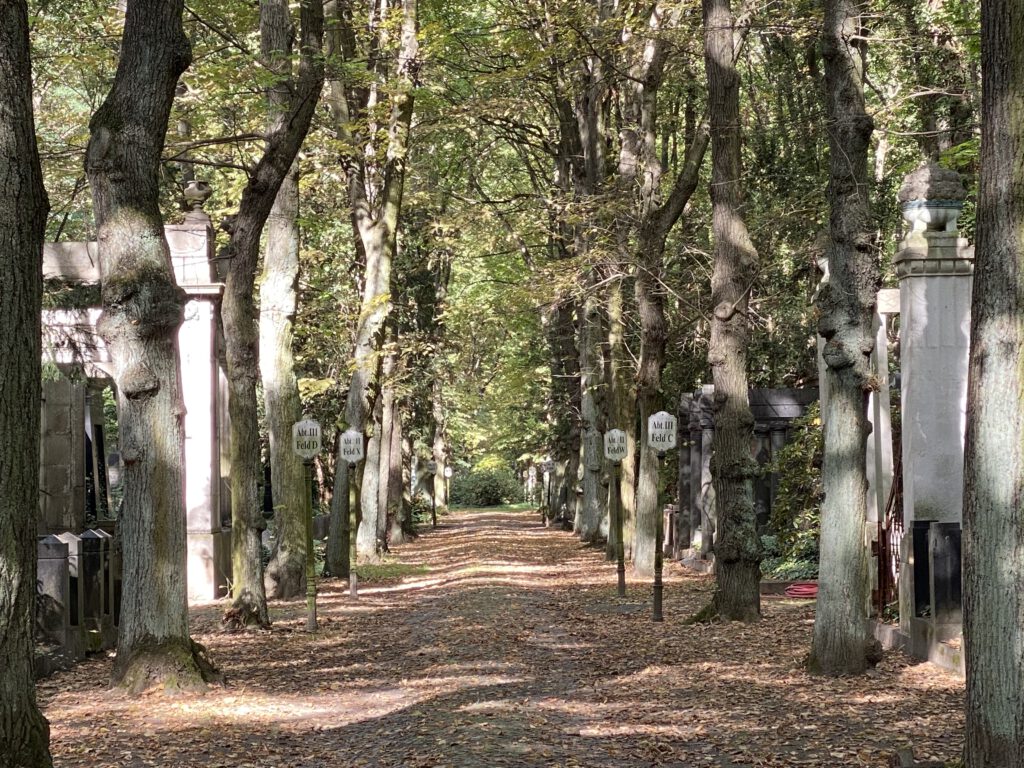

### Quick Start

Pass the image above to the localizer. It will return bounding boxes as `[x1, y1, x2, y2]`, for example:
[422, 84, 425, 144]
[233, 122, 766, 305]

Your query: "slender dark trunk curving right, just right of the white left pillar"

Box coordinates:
[220, 0, 324, 627]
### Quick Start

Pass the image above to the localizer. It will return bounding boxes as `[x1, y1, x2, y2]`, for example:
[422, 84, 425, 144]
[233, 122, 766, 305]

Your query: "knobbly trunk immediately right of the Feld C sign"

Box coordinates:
[704, 0, 761, 622]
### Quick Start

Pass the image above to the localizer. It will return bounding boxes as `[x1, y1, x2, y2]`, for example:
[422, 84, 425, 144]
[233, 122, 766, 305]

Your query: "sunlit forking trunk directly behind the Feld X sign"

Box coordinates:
[327, 0, 420, 565]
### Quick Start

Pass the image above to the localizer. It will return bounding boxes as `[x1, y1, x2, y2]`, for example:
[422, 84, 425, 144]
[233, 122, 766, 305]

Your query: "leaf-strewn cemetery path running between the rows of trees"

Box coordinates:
[40, 510, 963, 768]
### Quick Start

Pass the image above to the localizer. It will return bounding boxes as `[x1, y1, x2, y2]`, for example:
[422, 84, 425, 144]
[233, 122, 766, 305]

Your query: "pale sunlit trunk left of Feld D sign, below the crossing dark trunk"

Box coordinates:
[259, 162, 306, 599]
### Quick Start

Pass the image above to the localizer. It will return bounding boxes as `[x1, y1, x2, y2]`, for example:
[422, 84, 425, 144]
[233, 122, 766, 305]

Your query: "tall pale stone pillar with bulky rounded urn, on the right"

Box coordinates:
[895, 164, 974, 655]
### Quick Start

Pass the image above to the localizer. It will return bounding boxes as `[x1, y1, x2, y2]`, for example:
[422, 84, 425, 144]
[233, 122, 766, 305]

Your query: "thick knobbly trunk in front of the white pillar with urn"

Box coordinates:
[85, 0, 219, 692]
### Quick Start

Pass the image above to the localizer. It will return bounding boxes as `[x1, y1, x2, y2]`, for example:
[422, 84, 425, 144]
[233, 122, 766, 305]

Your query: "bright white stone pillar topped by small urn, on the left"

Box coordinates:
[165, 189, 230, 600]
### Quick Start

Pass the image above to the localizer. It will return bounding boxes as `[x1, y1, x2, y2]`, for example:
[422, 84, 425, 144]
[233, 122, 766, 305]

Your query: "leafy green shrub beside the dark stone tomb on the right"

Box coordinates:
[762, 403, 824, 579]
